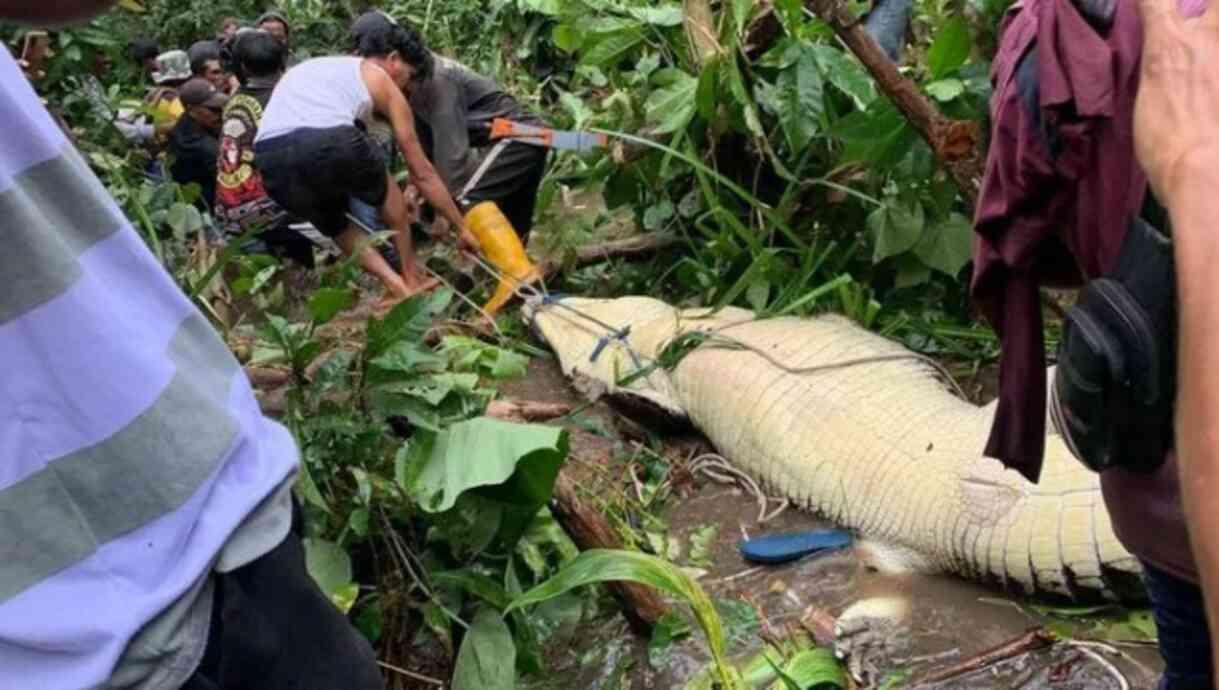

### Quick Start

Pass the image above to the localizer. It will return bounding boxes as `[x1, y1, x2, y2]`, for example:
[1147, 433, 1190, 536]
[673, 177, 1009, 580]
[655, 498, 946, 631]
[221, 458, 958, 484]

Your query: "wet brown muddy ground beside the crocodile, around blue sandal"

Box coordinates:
[501, 358, 1160, 690]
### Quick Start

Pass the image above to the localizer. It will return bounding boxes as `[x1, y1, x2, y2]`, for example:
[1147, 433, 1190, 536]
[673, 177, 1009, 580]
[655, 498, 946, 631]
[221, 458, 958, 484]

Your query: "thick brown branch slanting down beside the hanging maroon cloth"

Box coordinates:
[805, 0, 985, 208]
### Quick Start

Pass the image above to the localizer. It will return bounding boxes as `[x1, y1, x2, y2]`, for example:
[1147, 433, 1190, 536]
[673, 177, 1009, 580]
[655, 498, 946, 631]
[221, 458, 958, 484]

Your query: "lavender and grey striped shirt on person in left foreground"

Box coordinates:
[0, 50, 296, 690]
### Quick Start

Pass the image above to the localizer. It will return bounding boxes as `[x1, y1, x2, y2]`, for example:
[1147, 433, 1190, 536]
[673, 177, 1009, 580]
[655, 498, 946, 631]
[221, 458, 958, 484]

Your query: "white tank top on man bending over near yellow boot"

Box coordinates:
[255, 57, 373, 141]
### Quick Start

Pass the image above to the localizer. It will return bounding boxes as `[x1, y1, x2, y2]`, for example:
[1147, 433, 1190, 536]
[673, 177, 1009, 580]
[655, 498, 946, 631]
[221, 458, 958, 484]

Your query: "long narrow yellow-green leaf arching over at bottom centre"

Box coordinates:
[507, 549, 744, 690]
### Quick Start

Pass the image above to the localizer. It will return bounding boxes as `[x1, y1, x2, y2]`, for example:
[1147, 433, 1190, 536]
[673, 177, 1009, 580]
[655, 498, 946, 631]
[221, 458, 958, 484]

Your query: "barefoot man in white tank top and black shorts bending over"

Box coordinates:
[255, 32, 477, 300]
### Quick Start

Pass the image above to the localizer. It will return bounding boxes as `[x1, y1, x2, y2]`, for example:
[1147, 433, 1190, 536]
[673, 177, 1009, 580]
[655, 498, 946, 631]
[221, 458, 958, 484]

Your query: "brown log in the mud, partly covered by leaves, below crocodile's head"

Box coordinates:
[550, 472, 669, 635]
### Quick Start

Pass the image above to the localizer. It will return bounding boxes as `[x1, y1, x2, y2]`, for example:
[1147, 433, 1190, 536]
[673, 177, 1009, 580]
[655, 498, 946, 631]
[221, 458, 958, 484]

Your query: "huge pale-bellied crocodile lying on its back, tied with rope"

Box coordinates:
[524, 297, 1145, 602]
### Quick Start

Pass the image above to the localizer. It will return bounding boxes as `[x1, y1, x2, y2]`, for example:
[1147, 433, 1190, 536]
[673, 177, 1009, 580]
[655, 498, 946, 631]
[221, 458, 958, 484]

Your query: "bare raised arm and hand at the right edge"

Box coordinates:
[1135, 0, 1219, 677]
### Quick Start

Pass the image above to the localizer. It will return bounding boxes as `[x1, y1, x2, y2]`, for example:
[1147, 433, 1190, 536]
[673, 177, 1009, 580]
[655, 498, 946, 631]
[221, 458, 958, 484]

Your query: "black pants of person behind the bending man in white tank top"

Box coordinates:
[452, 141, 549, 241]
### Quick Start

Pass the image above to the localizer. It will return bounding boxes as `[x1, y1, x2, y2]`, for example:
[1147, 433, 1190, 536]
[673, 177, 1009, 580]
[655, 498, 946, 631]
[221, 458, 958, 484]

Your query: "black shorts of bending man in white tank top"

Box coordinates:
[254, 124, 389, 238]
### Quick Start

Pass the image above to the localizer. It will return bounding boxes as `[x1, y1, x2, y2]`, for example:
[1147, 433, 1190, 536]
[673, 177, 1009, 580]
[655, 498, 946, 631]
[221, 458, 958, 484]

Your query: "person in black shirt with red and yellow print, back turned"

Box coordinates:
[215, 29, 313, 267]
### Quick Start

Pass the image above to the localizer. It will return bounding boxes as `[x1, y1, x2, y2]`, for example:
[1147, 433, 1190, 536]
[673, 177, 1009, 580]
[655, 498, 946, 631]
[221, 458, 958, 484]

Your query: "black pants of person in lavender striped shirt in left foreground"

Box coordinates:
[183, 533, 384, 690]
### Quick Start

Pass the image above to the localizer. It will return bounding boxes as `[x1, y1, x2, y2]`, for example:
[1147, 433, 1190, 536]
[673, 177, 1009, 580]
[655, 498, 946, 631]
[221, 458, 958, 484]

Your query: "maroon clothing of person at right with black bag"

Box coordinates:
[972, 0, 1207, 583]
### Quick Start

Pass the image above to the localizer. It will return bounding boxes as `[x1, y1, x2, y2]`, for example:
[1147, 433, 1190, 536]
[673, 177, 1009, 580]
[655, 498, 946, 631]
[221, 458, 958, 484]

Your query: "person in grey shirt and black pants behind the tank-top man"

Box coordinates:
[351, 10, 547, 240]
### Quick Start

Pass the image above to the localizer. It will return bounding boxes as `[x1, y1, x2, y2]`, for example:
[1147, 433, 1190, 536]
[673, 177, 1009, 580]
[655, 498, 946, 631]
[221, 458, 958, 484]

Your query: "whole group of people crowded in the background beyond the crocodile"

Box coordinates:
[124, 11, 547, 307]
